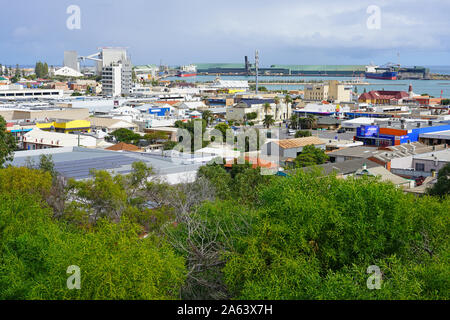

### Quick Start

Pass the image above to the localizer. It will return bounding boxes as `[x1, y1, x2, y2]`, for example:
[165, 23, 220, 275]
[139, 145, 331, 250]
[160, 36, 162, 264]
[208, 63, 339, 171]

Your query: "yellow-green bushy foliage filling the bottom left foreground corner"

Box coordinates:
[0, 193, 186, 300]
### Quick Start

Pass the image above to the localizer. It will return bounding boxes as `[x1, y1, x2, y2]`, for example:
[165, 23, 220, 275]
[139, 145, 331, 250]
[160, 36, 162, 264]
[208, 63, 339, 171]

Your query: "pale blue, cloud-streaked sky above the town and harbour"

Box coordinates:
[0, 0, 450, 66]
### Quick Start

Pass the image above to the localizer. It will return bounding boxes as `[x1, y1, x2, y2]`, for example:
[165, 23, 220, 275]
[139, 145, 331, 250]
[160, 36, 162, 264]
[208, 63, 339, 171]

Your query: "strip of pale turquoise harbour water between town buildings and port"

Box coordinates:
[166, 74, 450, 98]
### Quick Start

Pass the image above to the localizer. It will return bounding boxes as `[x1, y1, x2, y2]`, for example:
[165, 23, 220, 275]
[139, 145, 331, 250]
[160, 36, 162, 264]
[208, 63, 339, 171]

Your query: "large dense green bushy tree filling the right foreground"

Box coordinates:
[224, 172, 450, 300]
